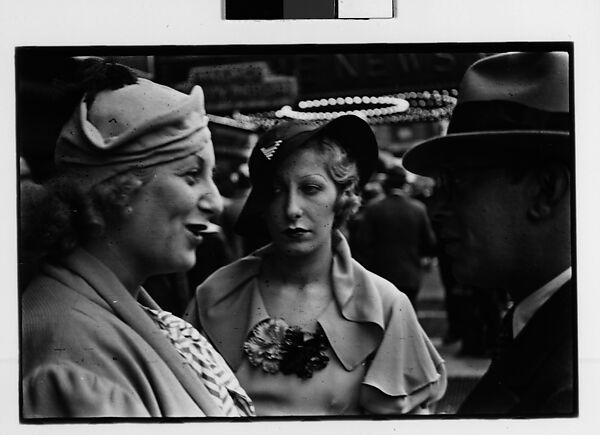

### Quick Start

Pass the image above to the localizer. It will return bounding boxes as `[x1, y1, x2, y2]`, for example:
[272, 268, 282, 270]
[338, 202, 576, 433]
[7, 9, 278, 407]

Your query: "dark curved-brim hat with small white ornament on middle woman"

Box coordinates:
[235, 115, 379, 235]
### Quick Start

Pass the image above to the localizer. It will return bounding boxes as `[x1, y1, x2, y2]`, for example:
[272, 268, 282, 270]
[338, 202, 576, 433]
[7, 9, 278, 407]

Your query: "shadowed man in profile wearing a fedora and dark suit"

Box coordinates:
[403, 52, 577, 416]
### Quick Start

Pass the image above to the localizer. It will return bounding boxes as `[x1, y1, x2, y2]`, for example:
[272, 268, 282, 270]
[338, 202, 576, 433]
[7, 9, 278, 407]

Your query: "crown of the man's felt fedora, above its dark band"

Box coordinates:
[458, 52, 569, 112]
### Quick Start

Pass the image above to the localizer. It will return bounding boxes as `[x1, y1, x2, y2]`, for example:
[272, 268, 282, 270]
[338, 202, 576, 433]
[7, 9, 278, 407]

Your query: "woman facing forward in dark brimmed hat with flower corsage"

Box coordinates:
[186, 115, 446, 415]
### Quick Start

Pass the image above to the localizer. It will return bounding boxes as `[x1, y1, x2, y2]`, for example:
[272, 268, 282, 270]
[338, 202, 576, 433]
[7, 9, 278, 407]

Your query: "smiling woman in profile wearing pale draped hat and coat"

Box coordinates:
[21, 64, 254, 419]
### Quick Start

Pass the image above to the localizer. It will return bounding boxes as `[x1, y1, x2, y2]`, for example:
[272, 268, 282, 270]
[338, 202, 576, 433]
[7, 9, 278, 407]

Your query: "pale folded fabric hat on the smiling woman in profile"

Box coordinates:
[54, 79, 212, 187]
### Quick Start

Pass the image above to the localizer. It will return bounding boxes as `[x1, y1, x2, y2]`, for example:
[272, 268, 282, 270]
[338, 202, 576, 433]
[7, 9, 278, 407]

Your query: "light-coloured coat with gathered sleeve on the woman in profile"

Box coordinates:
[21, 249, 222, 418]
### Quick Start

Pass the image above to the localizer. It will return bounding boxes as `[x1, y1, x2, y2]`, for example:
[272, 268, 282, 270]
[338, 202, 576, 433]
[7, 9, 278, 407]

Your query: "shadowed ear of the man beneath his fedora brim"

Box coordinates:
[528, 163, 570, 221]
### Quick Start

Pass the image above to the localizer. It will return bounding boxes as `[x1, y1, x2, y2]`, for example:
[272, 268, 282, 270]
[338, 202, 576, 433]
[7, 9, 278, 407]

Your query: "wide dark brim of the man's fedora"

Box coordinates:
[402, 130, 572, 177]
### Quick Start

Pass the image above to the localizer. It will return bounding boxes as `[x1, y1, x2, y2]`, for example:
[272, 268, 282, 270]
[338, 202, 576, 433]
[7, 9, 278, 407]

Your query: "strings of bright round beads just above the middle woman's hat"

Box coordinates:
[233, 89, 458, 129]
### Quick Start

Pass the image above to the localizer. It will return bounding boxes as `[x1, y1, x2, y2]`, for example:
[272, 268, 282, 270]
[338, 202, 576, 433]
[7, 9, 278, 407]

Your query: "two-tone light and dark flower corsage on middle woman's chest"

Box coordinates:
[243, 318, 329, 379]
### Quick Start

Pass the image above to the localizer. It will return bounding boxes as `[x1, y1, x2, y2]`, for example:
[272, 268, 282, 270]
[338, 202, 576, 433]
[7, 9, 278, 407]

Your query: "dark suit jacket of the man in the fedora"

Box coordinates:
[458, 282, 577, 417]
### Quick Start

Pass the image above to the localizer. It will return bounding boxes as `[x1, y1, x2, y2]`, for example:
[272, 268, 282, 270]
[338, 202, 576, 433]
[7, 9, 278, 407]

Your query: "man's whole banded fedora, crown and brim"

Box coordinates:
[402, 52, 571, 176]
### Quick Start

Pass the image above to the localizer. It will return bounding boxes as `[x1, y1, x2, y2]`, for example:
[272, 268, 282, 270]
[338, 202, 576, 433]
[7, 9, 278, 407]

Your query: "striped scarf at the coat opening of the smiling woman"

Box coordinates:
[140, 304, 256, 417]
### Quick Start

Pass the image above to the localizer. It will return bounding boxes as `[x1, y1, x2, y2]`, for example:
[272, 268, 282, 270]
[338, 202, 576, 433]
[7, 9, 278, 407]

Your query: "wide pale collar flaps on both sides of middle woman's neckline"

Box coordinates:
[197, 232, 384, 370]
